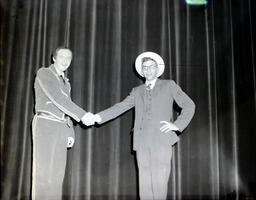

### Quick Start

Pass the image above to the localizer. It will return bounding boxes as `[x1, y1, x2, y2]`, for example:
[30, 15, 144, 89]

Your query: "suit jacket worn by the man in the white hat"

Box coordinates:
[98, 79, 195, 150]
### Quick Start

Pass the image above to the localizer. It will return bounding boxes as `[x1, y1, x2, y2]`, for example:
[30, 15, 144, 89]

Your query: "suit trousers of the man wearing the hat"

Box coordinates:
[137, 146, 172, 200]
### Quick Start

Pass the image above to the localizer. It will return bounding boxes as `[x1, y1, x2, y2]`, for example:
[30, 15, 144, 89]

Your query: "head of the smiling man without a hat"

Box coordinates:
[53, 49, 72, 72]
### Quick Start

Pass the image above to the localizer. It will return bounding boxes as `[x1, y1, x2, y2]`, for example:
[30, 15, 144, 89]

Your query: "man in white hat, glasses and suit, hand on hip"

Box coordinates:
[92, 52, 195, 200]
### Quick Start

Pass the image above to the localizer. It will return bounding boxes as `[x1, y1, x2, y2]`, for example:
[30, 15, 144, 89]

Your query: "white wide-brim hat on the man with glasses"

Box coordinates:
[135, 51, 164, 77]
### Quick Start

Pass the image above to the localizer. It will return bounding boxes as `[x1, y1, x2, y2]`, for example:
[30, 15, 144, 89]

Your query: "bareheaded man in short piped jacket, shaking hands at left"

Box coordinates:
[32, 47, 92, 200]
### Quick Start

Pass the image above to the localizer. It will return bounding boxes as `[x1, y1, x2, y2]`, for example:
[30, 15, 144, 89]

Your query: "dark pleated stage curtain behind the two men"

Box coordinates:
[0, 0, 256, 200]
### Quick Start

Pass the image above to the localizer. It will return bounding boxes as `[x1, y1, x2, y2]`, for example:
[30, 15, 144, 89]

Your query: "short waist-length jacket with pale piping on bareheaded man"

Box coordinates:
[34, 65, 86, 122]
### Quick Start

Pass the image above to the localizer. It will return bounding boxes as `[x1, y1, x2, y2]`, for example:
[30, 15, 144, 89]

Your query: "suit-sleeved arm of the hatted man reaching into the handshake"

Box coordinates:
[98, 89, 135, 124]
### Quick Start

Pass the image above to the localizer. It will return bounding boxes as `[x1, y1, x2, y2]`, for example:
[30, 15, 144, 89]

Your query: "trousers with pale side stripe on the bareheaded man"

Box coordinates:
[32, 116, 73, 200]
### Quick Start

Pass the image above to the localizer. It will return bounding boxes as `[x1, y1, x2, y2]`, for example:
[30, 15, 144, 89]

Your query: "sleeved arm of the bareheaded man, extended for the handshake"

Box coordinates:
[36, 68, 86, 122]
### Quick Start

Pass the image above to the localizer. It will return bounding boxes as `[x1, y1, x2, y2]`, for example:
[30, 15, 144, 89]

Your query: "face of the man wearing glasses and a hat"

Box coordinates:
[142, 60, 158, 81]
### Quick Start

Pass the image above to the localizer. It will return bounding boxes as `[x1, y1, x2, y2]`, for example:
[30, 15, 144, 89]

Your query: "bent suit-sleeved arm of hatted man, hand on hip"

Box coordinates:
[171, 81, 195, 132]
